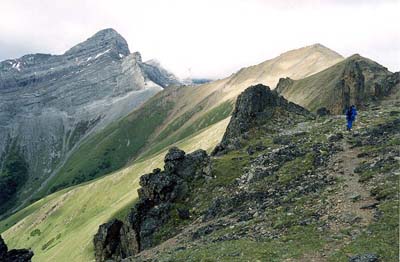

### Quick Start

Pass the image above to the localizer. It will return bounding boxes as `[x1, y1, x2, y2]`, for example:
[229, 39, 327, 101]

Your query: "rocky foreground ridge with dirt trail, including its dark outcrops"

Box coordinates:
[94, 85, 400, 261]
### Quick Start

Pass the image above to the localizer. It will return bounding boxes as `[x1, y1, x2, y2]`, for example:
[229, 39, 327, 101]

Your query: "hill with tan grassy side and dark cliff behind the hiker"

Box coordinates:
[277, 55, 400, 114]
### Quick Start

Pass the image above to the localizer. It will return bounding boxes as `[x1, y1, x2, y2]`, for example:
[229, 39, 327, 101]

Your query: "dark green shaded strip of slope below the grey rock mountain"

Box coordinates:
[38, 89, 177, 197]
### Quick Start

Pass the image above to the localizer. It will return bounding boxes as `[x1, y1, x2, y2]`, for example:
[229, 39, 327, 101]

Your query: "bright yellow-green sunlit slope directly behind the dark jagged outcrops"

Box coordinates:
[0, 118, 229, 262]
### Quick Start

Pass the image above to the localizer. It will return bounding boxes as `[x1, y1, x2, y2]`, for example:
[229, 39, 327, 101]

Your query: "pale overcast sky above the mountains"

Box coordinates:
[0, 0, 400, 78]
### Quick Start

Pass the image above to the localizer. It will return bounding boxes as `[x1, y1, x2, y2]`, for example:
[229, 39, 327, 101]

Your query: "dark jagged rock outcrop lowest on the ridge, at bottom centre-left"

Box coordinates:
[93, 148, 211, 261]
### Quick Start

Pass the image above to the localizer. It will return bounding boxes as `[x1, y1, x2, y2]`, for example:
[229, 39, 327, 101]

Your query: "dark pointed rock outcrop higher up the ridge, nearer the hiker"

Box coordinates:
[212, 84, 311, 155]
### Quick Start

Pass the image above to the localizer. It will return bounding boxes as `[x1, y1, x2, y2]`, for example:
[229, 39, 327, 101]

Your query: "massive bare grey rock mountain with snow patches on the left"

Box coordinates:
[0, 29, 180, 213]
